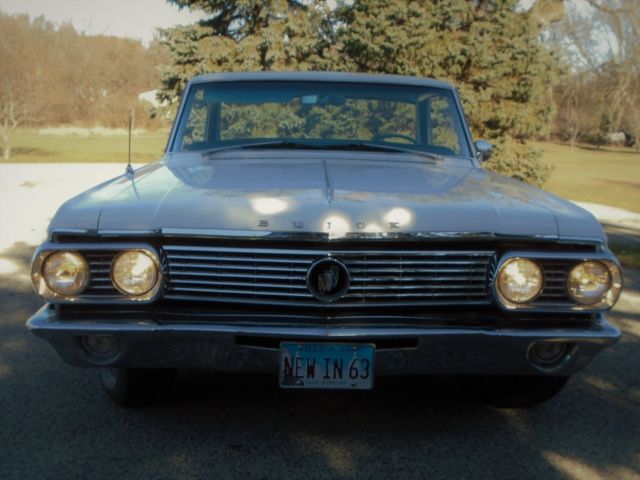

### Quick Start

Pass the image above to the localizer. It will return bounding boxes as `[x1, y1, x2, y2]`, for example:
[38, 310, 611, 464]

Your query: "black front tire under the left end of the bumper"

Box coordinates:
[100, 368, 176, 407]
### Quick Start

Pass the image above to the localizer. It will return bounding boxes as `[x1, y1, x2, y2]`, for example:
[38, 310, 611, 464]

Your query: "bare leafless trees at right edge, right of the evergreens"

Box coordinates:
[549, 0, 640, 148]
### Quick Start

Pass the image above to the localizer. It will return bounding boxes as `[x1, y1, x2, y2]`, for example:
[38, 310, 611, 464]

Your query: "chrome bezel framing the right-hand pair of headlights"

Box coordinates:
[491, 249, 623, 313]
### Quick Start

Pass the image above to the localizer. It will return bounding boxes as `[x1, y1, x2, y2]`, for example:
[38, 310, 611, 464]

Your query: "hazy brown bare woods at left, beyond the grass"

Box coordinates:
[0, 12, 170, 160]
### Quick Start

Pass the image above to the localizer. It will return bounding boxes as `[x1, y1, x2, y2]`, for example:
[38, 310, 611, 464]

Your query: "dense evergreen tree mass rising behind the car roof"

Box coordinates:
[163, 0, 557, 184]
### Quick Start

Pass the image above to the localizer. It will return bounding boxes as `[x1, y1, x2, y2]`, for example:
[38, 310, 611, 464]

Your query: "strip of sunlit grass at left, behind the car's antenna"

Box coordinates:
[5, 130, 168, 163]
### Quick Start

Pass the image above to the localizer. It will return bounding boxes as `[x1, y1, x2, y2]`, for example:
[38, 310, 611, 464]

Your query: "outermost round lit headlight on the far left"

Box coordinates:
[42, 252, 89, 296]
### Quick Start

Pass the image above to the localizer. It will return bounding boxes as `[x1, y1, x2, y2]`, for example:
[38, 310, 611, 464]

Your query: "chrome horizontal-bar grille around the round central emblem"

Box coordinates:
[163, 245, 494, 306]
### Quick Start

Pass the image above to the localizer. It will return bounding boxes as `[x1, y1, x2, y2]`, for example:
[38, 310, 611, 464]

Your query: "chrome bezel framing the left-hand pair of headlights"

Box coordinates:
[31, 242, 166, 305]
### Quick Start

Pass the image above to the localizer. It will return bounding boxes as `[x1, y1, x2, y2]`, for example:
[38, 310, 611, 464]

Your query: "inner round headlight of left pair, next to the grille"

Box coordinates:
[111, 250, 158, 297]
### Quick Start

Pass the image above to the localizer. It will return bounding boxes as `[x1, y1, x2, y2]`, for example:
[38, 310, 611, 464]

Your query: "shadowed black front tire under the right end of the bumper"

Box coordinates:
[460, 375, 569, 408]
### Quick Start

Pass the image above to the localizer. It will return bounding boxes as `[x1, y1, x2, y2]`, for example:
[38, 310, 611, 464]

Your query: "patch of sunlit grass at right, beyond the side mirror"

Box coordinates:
[533, 143, 640, 212]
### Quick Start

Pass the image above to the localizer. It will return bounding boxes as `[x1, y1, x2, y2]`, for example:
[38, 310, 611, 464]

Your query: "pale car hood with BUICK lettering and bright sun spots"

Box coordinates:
[51, 151, 604, 241]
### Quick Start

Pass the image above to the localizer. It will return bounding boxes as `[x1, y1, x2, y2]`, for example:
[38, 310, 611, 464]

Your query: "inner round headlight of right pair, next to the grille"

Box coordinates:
[497, 258, 544, 303]
